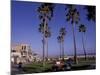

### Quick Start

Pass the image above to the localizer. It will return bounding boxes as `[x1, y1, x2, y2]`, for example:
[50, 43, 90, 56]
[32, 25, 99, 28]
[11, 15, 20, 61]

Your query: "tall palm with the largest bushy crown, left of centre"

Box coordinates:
[37, 3, 54, 66]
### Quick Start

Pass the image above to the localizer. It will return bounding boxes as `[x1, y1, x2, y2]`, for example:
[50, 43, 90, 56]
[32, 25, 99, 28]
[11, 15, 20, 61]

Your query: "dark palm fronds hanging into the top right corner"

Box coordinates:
[85, 6, 96, 22]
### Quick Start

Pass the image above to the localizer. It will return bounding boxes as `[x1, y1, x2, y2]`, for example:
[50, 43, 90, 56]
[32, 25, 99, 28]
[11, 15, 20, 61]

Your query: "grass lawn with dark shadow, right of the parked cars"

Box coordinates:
[72, 58, 96, 70]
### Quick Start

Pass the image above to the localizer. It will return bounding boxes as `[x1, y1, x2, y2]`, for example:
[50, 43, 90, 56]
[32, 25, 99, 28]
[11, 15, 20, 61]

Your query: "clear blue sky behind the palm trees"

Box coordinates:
[11, 1, 96, 56]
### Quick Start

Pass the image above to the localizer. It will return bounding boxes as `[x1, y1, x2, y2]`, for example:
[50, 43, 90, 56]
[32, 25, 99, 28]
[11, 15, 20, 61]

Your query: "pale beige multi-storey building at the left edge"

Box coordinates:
[11, 44, 34, 64]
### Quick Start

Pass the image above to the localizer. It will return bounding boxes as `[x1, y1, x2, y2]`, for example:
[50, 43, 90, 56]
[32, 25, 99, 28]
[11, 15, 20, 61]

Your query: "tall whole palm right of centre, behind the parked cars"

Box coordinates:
[66, 5, 80, 64]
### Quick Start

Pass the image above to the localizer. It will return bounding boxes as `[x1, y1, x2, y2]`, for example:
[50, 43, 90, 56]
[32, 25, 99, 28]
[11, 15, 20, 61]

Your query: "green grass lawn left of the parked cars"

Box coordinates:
[23, 63, 52, 73]
